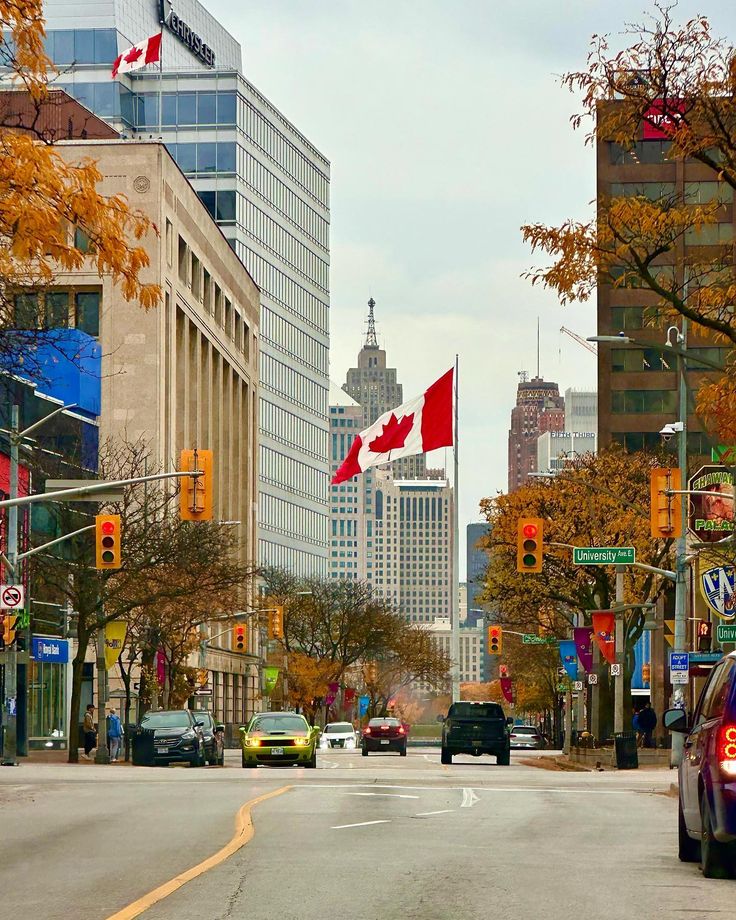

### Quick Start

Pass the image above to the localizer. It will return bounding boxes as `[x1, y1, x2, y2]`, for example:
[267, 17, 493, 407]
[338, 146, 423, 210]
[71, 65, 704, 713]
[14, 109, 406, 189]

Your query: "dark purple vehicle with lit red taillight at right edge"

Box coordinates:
[664, 652, 736, 878]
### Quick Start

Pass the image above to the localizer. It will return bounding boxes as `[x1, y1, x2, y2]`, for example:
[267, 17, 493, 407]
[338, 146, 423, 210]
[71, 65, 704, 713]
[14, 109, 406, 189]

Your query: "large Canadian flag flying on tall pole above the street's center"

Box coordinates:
[332, 369, 454, 485]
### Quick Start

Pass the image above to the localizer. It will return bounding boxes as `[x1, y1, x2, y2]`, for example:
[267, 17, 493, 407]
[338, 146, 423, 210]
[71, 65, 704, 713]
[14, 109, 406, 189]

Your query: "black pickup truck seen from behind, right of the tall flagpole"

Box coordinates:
[441, 702, 514, 766]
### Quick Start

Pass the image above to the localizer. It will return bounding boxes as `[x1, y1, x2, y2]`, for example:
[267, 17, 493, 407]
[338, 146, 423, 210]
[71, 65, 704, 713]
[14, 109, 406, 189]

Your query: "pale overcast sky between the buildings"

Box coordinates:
[203, 0, 736, 570]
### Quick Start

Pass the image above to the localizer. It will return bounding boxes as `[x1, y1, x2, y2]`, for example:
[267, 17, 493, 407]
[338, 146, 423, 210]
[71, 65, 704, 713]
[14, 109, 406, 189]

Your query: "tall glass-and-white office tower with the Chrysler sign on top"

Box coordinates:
[38, 0, 330, 575]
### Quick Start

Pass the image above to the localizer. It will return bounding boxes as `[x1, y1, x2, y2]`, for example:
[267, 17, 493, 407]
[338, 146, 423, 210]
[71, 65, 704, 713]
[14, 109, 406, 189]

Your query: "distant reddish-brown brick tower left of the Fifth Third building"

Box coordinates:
[508, 375, 565, 492]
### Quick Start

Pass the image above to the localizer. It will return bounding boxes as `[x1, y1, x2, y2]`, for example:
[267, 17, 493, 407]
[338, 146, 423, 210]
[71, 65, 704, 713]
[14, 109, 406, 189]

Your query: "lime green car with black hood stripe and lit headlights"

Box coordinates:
[240, 712, 320, 769]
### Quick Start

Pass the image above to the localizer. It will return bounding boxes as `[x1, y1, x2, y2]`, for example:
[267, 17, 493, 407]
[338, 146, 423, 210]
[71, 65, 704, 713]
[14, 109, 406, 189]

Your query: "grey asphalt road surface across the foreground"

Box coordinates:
[0, 749, 736, 920]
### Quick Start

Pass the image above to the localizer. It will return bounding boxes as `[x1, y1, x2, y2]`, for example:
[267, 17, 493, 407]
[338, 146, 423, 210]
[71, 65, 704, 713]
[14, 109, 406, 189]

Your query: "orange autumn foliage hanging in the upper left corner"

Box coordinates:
[0, 0, 160, 366]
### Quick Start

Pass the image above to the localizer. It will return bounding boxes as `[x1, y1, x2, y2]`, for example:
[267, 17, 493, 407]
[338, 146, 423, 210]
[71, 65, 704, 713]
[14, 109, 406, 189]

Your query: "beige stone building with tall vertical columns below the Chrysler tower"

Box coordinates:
[58, 139, 260, 725]
